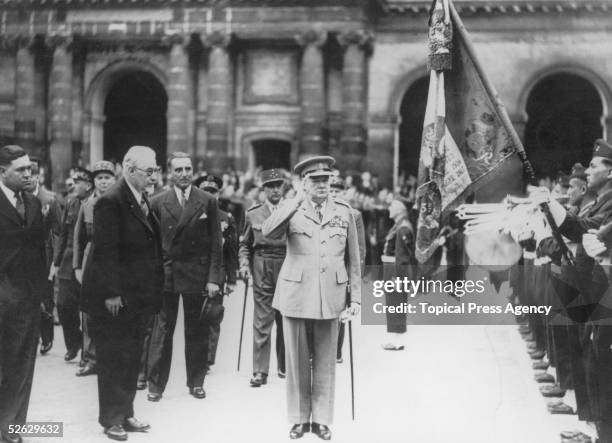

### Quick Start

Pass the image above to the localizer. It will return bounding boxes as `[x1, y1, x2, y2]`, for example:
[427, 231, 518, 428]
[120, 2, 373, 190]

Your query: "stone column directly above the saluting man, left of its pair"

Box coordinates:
[296, 31, 327, 160]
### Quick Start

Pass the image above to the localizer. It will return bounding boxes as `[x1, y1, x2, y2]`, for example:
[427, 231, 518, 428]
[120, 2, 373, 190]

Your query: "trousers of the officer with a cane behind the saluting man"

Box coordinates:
[253, 254, 285, 374]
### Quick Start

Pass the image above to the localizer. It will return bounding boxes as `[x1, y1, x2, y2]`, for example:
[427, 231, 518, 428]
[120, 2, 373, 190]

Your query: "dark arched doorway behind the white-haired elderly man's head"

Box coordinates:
[104, 71, 168, 166]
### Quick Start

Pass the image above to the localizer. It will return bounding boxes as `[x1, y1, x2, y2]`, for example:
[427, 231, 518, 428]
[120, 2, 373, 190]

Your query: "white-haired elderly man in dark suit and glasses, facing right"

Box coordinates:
[82, 146, 163, 440]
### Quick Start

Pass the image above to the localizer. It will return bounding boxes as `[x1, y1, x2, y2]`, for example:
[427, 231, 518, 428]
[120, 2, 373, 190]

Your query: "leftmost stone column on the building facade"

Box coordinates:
[15, 36, 39, 154]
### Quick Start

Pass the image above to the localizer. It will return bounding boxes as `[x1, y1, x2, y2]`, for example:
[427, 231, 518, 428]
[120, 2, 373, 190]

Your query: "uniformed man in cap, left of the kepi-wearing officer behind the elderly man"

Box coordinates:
[49, 169, 92, 361]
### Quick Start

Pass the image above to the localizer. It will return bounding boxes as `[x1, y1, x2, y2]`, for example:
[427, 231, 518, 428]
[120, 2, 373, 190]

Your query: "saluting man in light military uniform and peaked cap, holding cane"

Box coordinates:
[262, 156, 361, 440]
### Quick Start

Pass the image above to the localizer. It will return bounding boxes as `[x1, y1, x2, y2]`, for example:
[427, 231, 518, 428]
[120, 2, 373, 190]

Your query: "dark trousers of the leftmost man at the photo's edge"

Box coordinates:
[0, 282, 40, 432]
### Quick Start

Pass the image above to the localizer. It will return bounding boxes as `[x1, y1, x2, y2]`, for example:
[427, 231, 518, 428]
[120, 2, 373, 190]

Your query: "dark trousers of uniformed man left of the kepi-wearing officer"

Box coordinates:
[57, 278, 83, 351]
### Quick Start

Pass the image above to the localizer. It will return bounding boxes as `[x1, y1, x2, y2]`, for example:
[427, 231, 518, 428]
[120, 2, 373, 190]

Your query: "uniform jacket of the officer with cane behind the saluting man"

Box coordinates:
[238, 203, 287, 267]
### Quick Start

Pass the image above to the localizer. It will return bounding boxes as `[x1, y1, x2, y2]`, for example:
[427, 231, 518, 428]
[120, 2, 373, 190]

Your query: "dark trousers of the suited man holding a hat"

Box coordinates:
[148, 292, 210, 393]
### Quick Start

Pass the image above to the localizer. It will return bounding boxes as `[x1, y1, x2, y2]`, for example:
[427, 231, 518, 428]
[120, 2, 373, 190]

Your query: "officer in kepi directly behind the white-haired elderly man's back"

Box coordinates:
[72, 160, 115, 377]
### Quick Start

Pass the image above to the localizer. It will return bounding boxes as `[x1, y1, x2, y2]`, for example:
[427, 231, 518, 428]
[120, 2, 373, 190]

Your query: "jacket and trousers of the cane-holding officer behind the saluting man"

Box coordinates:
[238, 202, 287, 375]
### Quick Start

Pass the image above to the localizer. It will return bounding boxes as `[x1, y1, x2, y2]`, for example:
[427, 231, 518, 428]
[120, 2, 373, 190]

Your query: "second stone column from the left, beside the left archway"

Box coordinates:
[47, 36, 72, 190]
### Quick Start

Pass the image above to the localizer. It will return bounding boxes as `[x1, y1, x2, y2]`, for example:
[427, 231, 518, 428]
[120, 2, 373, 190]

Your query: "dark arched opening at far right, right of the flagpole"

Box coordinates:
[524, 72, 604, 178]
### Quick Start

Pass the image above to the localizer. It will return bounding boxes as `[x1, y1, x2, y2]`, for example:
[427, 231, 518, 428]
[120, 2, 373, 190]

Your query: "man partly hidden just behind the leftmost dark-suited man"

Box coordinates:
[28, 157, 62, 355]
